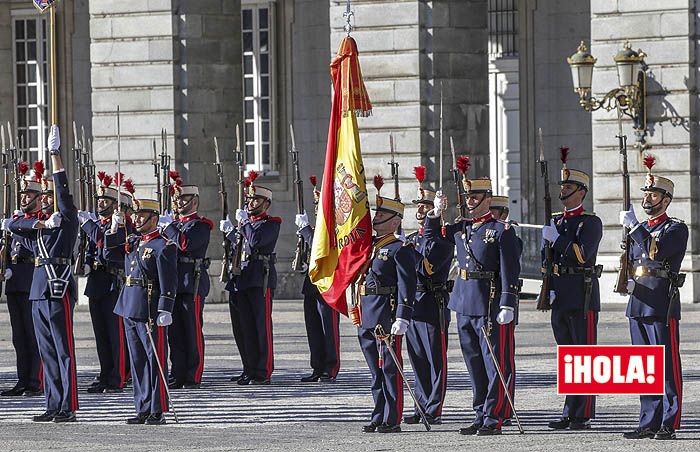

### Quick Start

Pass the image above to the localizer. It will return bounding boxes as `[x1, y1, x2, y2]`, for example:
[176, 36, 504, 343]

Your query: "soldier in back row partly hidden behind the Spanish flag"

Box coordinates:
[296, 176, 340, 383]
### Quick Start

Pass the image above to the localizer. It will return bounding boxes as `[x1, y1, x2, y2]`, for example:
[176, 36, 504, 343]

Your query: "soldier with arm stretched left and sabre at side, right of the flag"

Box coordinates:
[432, 175, 521, 436]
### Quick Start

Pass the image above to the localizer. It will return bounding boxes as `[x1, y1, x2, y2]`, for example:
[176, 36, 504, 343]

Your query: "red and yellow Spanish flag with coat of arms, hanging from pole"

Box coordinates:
[309, 36, 372, 316]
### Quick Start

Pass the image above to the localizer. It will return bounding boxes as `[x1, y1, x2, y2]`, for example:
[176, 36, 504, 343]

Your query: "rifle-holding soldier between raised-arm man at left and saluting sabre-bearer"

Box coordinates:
[78, 171, 133, 394]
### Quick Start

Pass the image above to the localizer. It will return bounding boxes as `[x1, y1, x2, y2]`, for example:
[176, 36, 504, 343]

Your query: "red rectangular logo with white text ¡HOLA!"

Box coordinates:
[557, 345, 664, 395]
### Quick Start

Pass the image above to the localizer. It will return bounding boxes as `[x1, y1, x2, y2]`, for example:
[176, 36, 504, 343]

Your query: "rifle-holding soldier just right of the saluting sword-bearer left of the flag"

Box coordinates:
[158, 173, 214, 389]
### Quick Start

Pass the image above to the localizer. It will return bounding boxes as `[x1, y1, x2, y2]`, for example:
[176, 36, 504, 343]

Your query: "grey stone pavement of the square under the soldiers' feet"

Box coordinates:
[0, 300, 700, 451]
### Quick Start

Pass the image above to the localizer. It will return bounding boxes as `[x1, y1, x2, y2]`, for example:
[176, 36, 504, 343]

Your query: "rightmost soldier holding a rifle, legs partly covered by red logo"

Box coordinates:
[620, 155, 688, 440]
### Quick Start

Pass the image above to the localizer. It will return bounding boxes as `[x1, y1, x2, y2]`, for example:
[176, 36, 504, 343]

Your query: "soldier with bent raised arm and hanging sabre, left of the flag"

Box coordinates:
[105, 199, 178, 425]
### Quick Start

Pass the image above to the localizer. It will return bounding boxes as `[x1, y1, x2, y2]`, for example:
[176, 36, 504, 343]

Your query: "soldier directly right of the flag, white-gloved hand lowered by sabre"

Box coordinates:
[358, 176, 416, 433]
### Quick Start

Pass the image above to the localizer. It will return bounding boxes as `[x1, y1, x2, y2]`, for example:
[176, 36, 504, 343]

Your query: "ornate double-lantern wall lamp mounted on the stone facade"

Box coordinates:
[566, 41, 648, 147]
